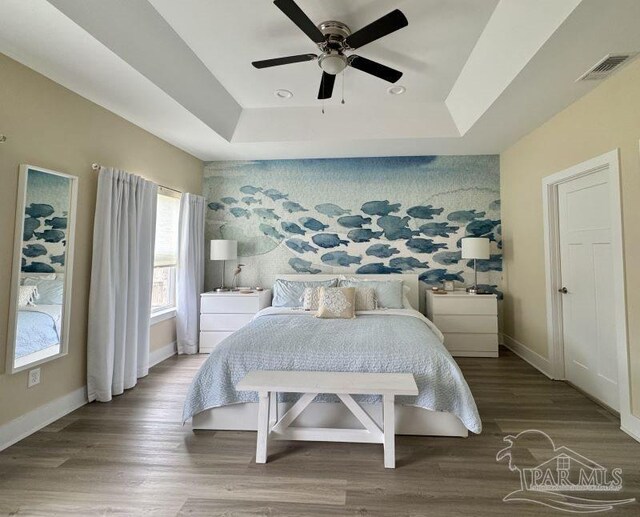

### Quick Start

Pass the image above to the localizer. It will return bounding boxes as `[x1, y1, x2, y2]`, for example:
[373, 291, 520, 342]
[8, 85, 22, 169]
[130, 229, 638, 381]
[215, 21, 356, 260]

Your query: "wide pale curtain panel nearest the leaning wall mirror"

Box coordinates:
[87, 167, 158, 402]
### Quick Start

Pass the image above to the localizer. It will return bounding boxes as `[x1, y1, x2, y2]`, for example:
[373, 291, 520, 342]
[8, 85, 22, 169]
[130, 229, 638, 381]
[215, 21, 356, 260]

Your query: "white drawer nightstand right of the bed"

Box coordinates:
[427, 291, 498, 357]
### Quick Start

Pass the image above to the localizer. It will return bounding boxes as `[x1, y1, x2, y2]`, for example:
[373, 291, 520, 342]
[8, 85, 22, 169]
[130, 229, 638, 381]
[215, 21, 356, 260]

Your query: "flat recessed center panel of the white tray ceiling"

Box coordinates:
[149, 0, 498, 108]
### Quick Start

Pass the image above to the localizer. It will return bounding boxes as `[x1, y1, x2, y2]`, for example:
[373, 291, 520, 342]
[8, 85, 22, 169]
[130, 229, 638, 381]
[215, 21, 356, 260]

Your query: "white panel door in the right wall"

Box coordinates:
[558, 170, 619, 410]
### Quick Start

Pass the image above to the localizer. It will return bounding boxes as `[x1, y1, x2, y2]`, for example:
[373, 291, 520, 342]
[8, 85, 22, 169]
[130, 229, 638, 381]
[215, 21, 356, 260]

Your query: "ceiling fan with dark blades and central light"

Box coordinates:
[252, 0, 409, 99]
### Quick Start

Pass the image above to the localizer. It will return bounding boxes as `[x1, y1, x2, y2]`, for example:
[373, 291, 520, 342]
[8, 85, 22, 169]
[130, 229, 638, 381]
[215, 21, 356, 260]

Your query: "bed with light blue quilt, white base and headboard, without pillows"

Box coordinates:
[183, 274, 482, 436]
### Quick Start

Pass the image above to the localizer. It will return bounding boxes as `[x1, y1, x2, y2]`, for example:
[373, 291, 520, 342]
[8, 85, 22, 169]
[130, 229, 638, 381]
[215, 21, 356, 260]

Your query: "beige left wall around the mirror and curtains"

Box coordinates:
[0, 54, 202, 425]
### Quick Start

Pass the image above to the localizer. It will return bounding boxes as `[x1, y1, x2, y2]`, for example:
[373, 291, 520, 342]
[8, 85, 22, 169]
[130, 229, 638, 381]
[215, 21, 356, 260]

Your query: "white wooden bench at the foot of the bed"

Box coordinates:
[236, 370, 418, 469]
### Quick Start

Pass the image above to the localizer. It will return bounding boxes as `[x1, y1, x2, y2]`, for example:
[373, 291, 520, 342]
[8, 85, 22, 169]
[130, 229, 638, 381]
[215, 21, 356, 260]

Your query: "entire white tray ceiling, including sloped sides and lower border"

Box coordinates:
[0, 0, 640, 160]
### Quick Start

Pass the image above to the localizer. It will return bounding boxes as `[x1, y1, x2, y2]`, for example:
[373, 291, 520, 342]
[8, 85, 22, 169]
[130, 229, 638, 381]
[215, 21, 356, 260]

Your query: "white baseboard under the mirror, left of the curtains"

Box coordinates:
[0, 386, 87, 451]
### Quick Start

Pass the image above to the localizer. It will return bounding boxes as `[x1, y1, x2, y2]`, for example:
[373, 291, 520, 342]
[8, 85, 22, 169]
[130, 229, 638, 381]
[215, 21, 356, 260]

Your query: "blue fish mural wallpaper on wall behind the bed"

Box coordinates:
[202, 155, 502, 302]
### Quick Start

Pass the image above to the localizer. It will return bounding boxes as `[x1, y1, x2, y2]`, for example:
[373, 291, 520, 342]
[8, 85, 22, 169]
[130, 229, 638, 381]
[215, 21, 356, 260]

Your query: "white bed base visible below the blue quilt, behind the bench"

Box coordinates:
[193, 402, 469, 438]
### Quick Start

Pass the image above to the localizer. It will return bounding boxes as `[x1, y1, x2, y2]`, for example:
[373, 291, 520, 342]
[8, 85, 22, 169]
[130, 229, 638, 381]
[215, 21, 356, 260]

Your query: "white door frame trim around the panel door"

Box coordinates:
[542, 149, 632, 428]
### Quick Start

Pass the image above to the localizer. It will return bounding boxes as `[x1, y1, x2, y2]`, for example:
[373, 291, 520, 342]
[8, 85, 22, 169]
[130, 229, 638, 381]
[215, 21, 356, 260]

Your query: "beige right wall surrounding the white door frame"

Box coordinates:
[501, 60, 640, 416]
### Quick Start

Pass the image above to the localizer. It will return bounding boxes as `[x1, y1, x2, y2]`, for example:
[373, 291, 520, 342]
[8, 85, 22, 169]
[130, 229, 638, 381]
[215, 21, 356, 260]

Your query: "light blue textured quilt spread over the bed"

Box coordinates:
[183, 309, 482, 433]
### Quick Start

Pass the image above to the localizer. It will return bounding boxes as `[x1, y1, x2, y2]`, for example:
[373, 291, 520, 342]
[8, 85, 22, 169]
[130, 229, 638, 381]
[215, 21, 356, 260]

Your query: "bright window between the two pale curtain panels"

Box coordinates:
[151, 193, 180, 314]
